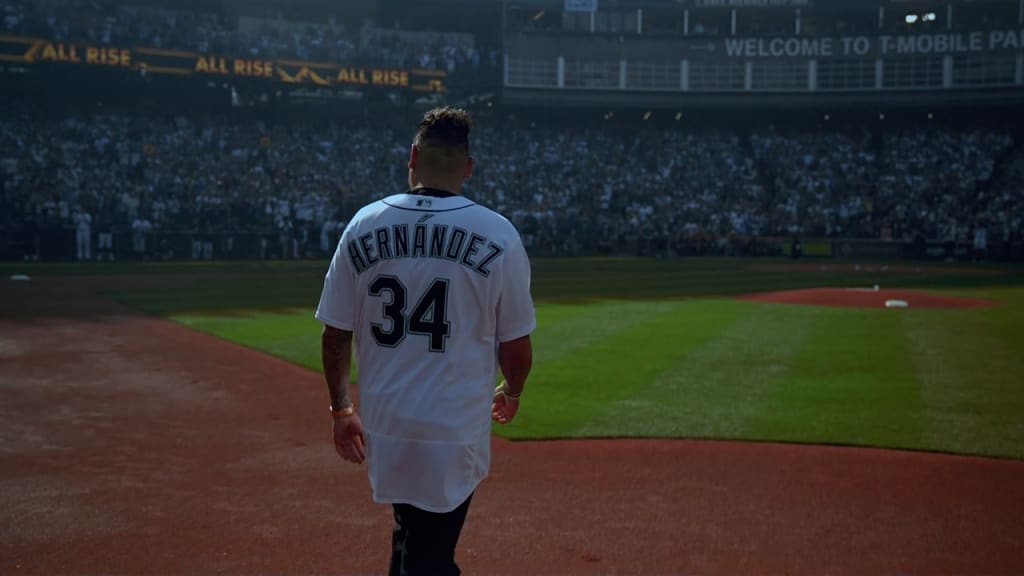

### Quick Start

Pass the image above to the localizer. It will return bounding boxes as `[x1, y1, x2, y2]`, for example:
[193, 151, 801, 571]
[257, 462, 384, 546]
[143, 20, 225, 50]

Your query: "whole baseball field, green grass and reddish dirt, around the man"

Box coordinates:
[0, 258, 1024, 575]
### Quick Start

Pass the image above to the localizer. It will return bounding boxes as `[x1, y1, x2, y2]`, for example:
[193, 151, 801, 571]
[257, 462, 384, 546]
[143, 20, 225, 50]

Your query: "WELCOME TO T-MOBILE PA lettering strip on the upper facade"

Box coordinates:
[689, 29, 1024, 58]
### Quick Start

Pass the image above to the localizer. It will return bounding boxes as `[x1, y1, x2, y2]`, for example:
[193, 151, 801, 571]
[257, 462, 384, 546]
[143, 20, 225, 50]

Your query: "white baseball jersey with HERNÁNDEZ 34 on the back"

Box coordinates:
[316, 194, 537, 512]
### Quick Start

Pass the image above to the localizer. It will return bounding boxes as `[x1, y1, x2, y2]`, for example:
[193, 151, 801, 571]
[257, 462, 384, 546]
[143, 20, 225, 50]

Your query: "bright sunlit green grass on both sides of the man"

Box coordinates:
[169, 290, 1024, 458]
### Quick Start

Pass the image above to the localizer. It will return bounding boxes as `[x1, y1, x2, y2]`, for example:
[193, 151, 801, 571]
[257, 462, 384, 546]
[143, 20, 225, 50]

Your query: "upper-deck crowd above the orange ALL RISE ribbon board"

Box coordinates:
[0, 0, 498, 73]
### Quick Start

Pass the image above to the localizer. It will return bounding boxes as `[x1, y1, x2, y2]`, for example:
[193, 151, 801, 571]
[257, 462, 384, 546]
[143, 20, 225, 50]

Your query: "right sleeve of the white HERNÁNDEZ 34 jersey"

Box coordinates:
[497, 235, 537, 342]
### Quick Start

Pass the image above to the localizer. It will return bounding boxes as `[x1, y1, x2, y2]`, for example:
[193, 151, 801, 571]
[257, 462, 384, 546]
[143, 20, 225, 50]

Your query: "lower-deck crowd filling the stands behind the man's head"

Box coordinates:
[0, 108, 1024, 257]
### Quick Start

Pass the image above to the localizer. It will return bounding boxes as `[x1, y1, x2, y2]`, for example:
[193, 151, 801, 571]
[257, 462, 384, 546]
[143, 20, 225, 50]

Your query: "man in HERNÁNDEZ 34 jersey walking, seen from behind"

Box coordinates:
[316, 108, 536, 576]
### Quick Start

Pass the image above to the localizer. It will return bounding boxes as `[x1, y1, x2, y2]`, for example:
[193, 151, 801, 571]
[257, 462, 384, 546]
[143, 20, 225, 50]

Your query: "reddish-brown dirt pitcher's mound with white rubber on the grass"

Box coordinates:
[739, 288, 998, 310]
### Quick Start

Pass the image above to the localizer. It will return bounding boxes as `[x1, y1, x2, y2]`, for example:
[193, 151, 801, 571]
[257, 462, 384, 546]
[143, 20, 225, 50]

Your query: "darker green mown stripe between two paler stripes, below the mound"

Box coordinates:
[745, 308, 923, 448]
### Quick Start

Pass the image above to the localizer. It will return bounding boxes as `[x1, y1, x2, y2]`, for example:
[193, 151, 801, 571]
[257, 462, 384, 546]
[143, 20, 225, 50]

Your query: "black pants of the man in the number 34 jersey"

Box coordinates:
[388, 494, 473, 576]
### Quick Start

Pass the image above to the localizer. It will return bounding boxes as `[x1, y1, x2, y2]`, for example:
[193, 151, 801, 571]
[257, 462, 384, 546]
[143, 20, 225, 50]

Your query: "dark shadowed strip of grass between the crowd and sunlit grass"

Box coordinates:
[9, 258, 1024, 316]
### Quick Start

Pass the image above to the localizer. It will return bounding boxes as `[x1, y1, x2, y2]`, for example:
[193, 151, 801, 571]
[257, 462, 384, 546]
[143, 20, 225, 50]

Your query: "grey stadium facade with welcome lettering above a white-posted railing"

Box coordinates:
[505, 25, 1024, 92]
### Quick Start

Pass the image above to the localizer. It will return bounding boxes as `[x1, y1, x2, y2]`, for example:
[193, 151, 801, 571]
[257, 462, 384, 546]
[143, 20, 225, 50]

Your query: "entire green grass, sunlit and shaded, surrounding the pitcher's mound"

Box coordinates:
[5, 259, 1024, 458]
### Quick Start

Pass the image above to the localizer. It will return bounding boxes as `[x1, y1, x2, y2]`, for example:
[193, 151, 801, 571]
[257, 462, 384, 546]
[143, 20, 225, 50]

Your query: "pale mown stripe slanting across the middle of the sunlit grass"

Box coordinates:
[578, 302, 819, 439]
